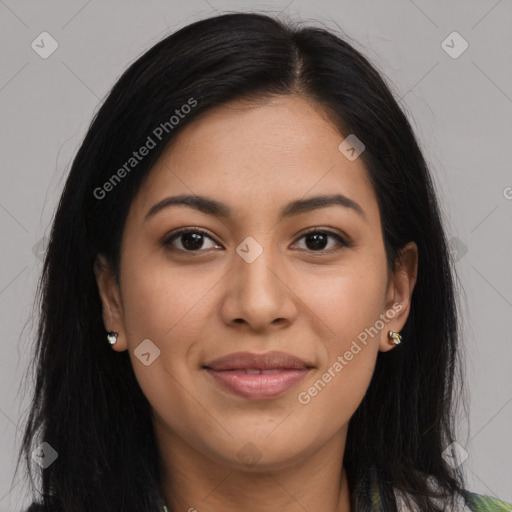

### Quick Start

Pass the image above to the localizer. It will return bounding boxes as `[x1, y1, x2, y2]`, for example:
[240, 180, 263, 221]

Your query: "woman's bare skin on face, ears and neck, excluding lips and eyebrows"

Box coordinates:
[95, 95, 418, 512]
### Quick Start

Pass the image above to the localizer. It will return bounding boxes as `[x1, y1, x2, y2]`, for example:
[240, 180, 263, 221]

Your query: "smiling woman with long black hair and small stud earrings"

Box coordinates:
[20, 14, 512, 512]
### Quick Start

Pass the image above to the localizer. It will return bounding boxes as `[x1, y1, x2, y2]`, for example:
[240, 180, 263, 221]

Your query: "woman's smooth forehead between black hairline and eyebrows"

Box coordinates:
[134, 95, 379, 228]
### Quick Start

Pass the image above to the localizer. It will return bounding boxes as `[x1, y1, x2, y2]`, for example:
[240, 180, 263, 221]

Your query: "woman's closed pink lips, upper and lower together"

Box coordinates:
[203, 351, 313, 400]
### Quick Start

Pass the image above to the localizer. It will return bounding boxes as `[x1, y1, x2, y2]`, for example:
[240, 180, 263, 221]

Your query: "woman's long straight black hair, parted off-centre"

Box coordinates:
[18, 13, 464, 512]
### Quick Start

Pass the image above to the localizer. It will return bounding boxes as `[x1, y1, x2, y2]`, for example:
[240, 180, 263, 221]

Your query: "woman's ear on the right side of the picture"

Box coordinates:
[379, 242, 418, 352]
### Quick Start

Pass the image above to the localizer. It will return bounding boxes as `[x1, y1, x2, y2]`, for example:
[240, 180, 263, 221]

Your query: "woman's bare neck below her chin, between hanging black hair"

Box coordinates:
[155, 420, 350, 512]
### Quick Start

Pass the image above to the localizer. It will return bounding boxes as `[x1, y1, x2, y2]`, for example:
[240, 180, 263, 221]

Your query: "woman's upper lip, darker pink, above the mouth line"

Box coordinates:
[204, 351, 312, 371]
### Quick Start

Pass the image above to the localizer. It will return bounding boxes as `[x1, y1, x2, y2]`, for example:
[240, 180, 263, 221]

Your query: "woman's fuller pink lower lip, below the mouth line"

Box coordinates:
[206, 368, 309, 400]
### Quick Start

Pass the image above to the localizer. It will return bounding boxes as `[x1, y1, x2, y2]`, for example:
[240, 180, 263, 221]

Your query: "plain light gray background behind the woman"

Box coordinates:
[0, 0, 512, 512]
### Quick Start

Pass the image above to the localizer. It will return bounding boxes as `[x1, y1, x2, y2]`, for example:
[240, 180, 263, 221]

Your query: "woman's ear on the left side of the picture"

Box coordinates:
[94, 254, 127, 352]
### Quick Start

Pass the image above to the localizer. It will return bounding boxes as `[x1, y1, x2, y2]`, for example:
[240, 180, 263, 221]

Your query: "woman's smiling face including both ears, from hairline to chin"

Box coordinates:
[97, 95, 416, 468]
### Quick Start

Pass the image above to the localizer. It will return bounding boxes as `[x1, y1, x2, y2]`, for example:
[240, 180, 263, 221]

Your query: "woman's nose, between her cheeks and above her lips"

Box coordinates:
[221, 243, 298, 332]
